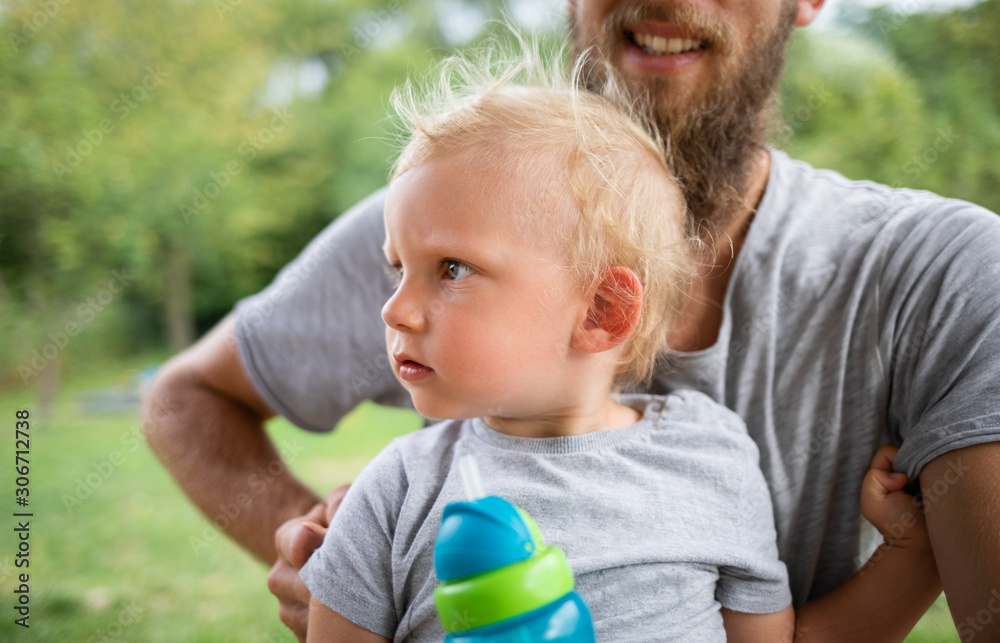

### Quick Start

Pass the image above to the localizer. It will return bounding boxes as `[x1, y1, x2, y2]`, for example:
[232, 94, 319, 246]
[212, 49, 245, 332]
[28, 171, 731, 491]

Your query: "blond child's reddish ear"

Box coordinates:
[573, 266, 642, 353]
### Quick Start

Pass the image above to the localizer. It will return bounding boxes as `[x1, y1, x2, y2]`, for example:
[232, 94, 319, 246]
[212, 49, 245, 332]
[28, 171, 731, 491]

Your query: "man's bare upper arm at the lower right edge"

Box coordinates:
[920, 443, 1000, 641]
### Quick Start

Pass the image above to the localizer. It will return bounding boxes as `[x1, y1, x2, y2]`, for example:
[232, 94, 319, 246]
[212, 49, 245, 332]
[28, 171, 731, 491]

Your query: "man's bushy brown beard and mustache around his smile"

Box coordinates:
[570, 0, 796, 240]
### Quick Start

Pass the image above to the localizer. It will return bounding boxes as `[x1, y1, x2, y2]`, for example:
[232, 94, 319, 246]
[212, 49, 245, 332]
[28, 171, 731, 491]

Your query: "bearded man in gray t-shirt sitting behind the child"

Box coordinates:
[144, 0, 1000, 640]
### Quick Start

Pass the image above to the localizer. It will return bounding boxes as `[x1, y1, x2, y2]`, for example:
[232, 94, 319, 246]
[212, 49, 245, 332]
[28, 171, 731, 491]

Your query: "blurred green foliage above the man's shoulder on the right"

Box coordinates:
[782, 0, 1000, 212]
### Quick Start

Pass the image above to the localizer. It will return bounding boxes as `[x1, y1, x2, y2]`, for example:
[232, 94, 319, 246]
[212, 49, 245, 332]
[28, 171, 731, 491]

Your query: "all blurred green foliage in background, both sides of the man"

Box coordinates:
[0, 0, 1000, 386]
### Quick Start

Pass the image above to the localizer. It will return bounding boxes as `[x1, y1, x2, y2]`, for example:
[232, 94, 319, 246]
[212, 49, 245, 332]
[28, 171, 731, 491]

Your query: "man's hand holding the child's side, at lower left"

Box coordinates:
[267, 484, 350, 643]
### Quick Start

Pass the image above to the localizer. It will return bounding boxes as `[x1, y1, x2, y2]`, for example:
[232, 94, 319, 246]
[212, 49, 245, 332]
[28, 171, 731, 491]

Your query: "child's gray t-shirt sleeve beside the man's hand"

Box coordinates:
[299, 443, 407, 638]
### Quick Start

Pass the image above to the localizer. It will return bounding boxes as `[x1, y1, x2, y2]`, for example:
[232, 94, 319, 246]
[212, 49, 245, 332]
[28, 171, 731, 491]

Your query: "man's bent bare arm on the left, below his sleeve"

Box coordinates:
[143, 315, 320, 564]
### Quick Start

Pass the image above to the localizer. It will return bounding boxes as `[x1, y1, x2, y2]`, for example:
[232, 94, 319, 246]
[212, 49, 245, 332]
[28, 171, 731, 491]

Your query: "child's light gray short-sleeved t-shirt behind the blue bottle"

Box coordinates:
[302, 391, 791, 643]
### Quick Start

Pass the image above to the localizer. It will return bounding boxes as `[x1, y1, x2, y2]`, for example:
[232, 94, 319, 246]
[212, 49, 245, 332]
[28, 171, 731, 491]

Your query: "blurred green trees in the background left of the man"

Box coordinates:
[0, 0, 458, 381]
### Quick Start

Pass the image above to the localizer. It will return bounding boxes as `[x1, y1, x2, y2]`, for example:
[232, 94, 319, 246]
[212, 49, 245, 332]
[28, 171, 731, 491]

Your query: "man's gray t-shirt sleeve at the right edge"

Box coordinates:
[889, 200, 1000, 480]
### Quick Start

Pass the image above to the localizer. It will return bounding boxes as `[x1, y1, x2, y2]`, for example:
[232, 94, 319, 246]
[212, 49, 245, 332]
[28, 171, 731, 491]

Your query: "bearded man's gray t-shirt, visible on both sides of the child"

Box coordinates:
[230, 151, 1000, 604]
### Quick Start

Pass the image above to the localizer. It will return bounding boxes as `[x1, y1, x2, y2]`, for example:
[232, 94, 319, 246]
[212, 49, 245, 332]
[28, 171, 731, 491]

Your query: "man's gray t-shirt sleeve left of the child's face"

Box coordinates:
[236, 189, 409, 431]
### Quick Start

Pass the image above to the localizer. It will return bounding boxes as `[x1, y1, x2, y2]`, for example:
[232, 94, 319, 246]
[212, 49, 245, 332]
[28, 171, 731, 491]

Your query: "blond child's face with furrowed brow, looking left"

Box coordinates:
[382, 154, 588, 419]
